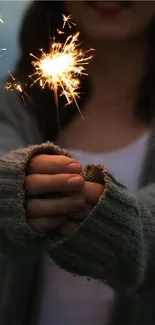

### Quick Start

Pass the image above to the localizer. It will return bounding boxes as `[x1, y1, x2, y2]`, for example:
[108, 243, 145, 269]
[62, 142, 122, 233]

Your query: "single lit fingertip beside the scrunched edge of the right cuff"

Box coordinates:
[84, 182, 104, 205]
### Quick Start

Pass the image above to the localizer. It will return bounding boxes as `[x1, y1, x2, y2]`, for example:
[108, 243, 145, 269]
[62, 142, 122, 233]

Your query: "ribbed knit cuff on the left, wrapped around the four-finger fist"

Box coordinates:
[0, 143, 69, 246]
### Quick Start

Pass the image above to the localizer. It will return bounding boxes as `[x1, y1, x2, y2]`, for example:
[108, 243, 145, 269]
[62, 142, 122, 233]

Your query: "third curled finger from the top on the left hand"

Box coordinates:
[26, 196, 85, 218]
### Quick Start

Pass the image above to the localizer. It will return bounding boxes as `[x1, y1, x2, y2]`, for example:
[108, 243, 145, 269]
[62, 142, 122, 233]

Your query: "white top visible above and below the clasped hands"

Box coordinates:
[39, 133, 149, 325]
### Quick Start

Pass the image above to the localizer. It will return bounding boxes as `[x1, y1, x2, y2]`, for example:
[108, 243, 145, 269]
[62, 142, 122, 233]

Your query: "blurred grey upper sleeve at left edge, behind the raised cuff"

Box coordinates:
[0, 91, 42, 157]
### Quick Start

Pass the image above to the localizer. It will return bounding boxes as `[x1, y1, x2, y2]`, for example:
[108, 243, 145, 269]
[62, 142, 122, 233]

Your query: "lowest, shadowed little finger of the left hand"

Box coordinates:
[29, 216, 66, 231]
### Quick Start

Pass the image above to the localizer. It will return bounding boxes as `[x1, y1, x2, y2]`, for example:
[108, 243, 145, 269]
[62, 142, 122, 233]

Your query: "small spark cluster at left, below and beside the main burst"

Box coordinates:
[4, 71, 31, 105]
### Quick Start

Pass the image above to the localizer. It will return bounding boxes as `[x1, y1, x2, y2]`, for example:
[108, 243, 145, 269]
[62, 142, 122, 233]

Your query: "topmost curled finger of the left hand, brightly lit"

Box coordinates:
[27, 155, 82, 174]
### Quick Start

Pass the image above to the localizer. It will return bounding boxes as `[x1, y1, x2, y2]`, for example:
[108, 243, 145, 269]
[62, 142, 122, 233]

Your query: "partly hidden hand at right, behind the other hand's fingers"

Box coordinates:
[58, 182, 104, 236]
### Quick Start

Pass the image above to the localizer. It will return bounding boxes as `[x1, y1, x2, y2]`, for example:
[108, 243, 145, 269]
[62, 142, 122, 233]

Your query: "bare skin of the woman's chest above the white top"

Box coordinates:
[61, 112, 149, 153]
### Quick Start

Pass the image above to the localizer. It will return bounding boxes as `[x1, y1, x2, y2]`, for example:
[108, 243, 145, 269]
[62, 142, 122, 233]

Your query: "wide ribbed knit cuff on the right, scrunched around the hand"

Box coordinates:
[48, 165, 145, 291]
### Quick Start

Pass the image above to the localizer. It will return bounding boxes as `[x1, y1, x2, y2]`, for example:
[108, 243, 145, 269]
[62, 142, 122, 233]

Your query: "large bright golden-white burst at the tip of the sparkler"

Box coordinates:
[29, 32, 92, 116]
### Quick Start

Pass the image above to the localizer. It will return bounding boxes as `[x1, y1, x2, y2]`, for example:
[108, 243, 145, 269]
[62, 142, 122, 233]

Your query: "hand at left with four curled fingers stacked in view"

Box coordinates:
[25, 155, 85, 231]
